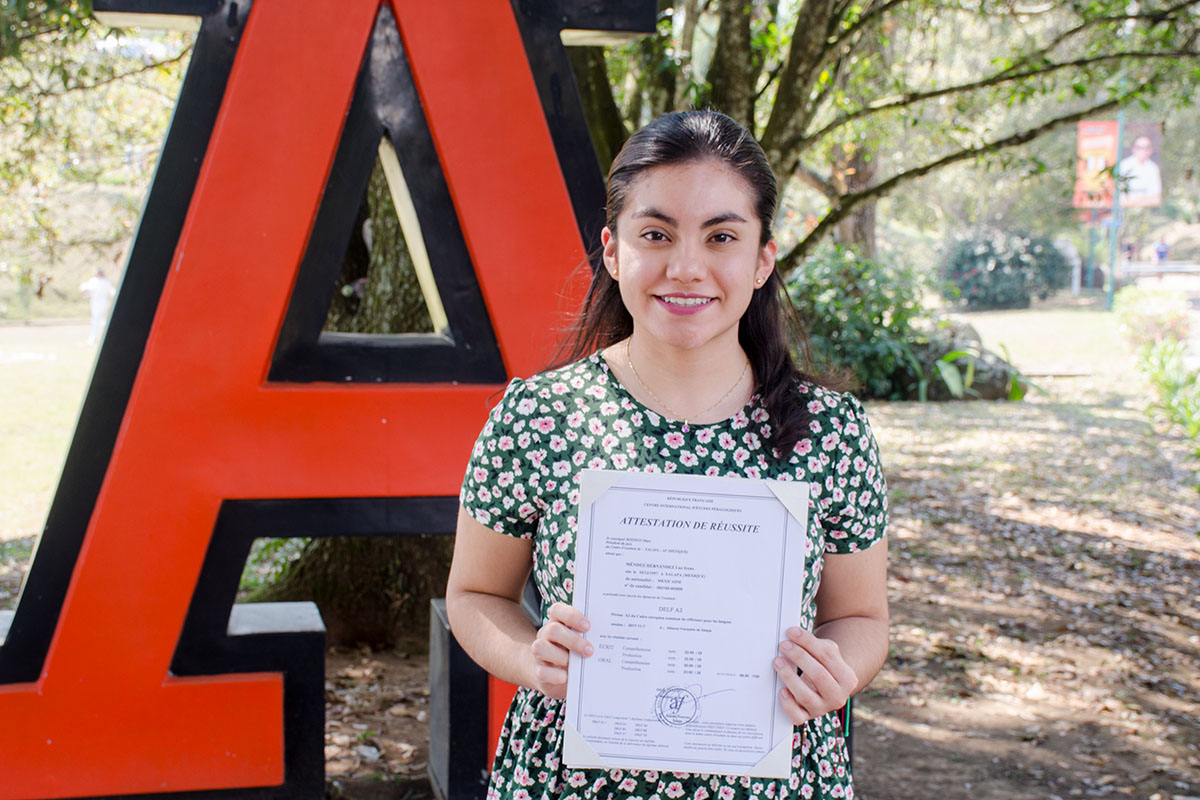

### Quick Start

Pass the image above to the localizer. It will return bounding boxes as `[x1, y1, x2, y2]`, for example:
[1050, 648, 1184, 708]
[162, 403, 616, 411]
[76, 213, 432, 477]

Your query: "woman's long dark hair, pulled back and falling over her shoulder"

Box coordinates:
[554, 110, 838, 458]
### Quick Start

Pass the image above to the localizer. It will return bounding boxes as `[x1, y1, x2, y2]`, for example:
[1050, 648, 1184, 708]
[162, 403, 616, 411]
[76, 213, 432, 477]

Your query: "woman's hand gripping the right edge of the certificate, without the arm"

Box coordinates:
[775, 627, 858, 724]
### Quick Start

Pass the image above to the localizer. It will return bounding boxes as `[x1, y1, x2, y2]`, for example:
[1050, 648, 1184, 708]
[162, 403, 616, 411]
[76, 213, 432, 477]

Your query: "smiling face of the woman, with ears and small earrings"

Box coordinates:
[601, 161, 775, 350]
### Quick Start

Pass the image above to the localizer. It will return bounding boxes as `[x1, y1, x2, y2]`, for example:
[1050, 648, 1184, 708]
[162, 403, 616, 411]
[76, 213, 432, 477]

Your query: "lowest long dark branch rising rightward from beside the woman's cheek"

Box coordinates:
[776, 80, 1151, 273]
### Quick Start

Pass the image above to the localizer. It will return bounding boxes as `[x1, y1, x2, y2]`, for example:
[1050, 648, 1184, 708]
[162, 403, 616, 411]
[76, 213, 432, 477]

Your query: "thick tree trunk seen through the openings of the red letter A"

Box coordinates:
[253, 155, 454, 646]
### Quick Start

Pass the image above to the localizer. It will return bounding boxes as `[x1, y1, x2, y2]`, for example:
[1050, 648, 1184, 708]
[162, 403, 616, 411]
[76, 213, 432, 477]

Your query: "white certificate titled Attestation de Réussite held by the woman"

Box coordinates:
[563, 470, 811, 778]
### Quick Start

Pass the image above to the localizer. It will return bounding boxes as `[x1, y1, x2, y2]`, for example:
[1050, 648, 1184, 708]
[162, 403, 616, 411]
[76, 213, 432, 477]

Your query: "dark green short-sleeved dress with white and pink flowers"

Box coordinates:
[461, 354, 887, 800]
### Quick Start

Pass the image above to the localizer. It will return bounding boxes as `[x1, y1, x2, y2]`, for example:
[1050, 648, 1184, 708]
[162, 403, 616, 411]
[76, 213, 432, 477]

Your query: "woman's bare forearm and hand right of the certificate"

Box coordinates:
[775, 537, 888, 723]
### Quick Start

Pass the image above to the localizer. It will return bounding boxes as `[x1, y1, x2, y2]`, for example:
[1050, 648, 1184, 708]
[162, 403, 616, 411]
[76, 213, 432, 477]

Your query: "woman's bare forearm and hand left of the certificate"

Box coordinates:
[446, 510, 592, 699]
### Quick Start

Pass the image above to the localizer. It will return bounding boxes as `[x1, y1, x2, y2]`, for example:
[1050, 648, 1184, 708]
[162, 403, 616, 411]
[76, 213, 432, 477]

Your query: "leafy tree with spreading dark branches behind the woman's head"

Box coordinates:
[576, 0, 1200, 269]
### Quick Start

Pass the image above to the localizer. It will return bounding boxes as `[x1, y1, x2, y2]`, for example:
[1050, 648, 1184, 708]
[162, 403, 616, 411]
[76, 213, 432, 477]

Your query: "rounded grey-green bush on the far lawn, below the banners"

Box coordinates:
[938, 230, 1070, 311]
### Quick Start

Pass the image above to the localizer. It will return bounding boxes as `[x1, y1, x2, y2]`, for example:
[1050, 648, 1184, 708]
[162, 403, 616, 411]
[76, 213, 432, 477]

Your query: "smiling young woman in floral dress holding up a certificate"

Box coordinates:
[446, 112, 888, 800]
